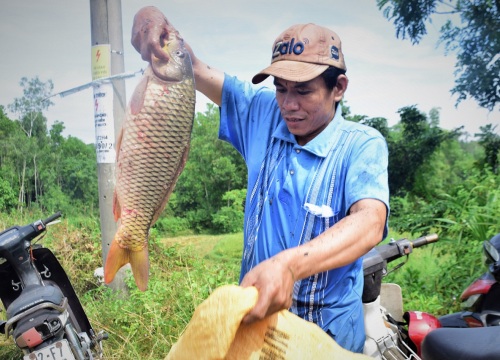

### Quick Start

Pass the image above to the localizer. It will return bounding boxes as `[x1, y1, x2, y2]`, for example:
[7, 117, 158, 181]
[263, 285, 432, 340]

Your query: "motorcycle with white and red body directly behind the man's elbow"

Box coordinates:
[362, 234, 440, 360]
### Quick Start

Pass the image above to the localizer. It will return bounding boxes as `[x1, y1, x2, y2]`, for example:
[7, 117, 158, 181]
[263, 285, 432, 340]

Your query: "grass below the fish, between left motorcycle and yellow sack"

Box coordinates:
[84, 234, 242, 359]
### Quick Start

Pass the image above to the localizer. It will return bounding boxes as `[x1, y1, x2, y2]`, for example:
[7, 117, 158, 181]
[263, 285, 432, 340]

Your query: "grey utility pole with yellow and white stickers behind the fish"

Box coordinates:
[90, 0, 126, 290]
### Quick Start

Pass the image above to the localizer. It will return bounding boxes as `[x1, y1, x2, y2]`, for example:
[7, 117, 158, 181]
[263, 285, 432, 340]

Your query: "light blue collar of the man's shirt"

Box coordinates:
[272, 106, 345, 157]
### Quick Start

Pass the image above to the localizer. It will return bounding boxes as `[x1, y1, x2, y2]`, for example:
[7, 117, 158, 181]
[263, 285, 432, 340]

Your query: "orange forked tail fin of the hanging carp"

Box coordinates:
[104, 239, 149, 291]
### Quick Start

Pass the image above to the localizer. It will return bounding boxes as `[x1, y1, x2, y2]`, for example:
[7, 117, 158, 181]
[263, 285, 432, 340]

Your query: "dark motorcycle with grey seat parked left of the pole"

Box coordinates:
[0, 212, 107, 360]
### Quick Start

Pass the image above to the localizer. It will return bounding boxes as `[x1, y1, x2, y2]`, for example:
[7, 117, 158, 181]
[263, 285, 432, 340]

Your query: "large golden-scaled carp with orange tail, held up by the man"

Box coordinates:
[104, 28, 196, 291]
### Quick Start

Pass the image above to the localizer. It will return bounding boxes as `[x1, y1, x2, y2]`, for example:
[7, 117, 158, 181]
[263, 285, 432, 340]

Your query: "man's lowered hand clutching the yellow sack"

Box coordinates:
[237, 255, 295, 324]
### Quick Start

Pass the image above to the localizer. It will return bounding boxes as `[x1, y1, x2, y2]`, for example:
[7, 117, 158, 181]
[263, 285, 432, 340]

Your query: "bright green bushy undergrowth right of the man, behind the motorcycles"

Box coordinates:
[388, 171, 500, 315]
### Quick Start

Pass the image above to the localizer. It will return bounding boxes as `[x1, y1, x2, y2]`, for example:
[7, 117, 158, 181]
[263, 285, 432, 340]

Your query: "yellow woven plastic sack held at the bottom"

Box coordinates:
[166, 285, 371, 360]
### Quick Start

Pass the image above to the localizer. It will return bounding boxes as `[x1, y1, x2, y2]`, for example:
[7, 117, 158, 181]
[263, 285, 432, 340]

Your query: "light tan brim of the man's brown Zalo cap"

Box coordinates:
[252, 60, 328, 84]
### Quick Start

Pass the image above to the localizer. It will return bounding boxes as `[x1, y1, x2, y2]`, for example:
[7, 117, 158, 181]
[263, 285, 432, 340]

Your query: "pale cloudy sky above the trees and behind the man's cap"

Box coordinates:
[0, 0, 500, 143]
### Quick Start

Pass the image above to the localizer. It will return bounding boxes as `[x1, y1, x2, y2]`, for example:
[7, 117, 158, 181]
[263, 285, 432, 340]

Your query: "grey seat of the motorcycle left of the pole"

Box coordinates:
[7, 285, 64, 319]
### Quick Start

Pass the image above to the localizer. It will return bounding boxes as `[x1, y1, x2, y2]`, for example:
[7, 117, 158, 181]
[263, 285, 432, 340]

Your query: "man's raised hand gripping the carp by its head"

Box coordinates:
[131, 6, 177, 63]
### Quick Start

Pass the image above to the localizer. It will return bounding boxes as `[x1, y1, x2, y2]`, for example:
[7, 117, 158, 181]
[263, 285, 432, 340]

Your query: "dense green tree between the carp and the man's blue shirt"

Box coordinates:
[167, 104, 246, 231]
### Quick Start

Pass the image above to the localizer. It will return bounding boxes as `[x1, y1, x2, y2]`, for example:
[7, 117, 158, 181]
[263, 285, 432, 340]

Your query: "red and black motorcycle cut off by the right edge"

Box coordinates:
[439, 234, 500, 328]
